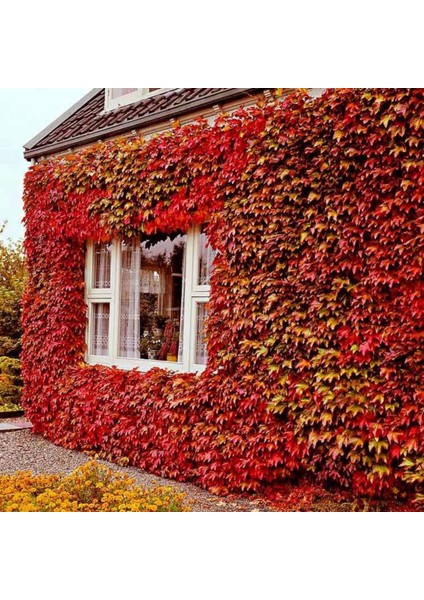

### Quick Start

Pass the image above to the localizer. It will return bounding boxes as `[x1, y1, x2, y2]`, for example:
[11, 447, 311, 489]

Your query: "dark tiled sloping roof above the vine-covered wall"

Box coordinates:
[24, 88, 262, 160]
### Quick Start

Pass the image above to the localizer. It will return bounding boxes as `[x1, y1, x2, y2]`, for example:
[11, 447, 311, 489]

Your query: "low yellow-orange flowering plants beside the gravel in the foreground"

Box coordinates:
[0, 461, 190, 512]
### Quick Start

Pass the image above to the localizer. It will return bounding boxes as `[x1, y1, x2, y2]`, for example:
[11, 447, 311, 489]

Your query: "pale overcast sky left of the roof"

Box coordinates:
[0, 88, 90, 240]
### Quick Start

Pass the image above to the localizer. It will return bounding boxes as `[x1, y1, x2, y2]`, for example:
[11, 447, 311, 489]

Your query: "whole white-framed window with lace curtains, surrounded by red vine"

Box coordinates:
[86, 227, 215, 371]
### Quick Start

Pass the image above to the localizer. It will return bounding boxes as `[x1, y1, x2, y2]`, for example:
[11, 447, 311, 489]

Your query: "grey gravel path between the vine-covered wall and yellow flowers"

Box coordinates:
[0, 419, 272, 512]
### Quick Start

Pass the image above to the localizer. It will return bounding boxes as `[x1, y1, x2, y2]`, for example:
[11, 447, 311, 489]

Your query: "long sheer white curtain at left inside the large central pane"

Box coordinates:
[119, 242, 141, 358]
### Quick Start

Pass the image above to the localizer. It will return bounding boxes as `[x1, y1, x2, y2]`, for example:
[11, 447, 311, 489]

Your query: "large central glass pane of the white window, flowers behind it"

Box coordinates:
[119, 235, 187, 362]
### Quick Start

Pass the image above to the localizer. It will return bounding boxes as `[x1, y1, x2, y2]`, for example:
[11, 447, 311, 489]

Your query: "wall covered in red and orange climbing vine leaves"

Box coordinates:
[23, 89, 424, 495]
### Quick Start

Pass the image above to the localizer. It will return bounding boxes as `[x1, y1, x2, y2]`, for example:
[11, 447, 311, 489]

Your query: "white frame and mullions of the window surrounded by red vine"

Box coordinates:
[85, 227, 210, 373]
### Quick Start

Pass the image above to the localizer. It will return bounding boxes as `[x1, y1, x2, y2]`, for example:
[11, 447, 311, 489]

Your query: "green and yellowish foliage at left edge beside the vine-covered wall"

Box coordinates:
[0, 223, 26, 411]
